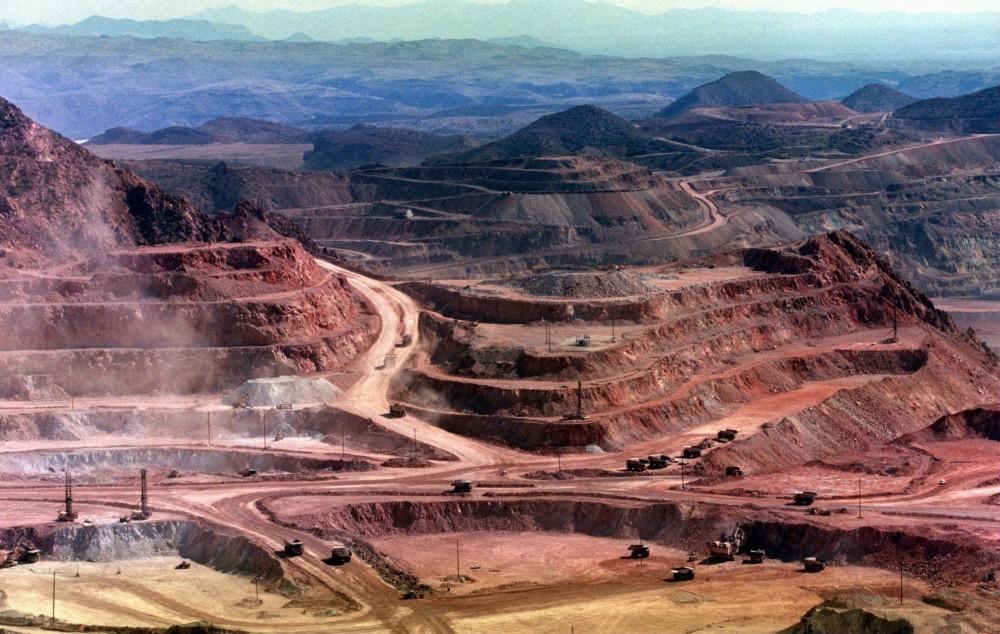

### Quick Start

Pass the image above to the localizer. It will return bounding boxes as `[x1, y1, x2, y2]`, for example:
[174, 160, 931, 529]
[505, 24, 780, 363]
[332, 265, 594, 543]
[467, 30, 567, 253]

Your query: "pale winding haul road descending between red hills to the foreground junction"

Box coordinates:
[0, 258, 1000, 633]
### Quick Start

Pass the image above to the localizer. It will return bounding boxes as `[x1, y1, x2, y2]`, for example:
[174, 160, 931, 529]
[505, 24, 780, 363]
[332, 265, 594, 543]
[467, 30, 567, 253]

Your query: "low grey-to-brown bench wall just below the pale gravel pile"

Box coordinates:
[0, 406, 455, 460]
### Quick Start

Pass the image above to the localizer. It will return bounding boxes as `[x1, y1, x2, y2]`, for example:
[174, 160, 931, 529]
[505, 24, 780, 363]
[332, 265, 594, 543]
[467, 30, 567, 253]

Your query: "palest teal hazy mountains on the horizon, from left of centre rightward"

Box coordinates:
[193, 0, 1000, 61]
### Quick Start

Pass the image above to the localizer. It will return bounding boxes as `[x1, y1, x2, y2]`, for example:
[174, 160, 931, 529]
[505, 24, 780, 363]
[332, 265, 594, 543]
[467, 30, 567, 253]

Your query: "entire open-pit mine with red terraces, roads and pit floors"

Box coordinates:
[0, 87, 1000, 633]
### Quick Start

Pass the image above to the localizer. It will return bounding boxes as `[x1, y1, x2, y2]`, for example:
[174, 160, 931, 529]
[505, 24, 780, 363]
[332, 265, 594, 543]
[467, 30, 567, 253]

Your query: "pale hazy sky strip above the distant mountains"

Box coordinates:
[0, 0, 1000, 24]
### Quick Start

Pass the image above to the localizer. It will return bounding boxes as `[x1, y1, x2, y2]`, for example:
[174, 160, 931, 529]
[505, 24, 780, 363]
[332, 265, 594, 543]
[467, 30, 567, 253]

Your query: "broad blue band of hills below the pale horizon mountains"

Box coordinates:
[0, 31, 1000, 139]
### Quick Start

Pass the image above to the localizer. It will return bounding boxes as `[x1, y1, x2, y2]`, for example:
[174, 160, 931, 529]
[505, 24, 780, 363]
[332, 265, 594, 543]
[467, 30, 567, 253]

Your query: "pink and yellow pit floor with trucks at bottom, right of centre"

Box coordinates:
[376, 532, 927, 634]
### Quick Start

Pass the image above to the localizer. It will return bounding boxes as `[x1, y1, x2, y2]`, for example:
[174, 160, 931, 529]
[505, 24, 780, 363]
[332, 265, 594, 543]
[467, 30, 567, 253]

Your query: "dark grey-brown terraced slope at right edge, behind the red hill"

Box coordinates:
[717, 136, 1000, 297]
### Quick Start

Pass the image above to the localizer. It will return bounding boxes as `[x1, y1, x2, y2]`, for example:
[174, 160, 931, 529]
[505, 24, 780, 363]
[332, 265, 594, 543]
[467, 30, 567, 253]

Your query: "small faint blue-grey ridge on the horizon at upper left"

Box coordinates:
[20, 15, 267, 42]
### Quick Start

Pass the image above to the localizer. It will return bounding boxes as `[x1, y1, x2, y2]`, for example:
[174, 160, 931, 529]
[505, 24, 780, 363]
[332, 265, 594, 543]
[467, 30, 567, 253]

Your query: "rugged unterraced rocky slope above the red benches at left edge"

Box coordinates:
[0, 99, 211, 266]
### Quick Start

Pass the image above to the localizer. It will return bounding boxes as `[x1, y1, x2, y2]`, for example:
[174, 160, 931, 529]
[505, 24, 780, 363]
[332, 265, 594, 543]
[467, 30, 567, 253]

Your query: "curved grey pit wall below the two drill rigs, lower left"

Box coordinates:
[0, 520, 289, 580]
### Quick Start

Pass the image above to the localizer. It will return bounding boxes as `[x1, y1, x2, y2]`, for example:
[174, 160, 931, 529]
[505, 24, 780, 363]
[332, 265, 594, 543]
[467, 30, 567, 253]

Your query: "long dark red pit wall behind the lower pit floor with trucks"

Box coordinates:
[272, 497, 1000, 579]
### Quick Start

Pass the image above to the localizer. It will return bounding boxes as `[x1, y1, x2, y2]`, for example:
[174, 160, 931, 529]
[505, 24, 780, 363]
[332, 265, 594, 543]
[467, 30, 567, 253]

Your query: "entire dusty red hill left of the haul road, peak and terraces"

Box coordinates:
[0, 101, 378, 398]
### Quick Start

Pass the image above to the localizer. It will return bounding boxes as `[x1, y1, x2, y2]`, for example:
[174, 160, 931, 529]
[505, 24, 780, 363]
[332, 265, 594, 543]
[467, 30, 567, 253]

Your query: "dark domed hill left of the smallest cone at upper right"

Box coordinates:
[660, 70, 809, 118]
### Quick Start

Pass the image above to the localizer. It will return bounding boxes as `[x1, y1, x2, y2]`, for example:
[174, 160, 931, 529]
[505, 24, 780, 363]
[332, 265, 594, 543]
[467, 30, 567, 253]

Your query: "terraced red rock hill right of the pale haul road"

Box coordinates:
[395, 232, 1000, 474]
